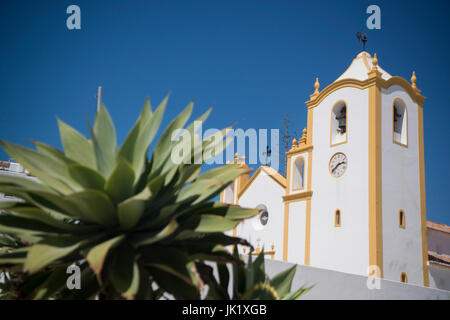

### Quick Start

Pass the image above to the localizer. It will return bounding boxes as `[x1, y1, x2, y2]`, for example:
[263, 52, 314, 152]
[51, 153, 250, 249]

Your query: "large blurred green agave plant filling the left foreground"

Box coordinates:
[0, 97, 257, 299]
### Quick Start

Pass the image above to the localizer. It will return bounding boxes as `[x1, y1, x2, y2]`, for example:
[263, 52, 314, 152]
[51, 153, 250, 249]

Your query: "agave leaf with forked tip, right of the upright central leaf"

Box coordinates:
[120, 96, 169, 179]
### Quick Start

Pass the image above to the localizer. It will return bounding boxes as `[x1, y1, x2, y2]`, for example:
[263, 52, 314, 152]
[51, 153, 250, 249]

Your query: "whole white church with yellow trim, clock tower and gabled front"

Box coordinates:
[220, 51, 450, 290]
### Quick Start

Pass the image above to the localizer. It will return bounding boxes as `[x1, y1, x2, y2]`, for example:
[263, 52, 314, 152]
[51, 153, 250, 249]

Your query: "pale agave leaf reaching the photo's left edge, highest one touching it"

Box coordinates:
[0, 141, 80, 194]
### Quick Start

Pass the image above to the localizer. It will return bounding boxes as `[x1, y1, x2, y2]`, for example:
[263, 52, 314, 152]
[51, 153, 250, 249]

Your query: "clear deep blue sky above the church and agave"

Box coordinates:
[0, 0, 450, 225]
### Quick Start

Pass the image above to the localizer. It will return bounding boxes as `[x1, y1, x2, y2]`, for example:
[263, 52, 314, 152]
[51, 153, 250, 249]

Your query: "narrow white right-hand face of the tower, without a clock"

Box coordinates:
[381, 86, 423, 285]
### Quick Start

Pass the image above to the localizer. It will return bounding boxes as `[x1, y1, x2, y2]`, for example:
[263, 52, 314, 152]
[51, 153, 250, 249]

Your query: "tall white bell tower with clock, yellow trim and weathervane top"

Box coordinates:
[298, 52, 428, 285]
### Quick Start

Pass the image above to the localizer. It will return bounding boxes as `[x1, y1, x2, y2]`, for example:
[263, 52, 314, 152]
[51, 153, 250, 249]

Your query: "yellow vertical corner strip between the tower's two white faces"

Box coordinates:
[368, 69, 383, 278]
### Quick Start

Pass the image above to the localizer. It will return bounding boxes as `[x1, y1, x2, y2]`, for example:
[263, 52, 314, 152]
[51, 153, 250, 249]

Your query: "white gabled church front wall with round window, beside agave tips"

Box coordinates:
[237, 170, 285, 260]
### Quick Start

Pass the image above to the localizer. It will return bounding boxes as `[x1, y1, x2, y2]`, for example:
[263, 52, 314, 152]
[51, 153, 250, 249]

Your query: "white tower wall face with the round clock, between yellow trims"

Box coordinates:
[310, 87, 369, 275]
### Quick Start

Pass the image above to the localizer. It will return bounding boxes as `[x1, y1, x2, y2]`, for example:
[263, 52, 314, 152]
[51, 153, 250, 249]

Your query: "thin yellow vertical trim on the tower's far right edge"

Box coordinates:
[417, 104, 430, 287]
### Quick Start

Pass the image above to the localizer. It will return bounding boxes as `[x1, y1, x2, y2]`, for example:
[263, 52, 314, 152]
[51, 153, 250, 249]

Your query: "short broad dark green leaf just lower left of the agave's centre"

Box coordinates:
[65, 190, 118, 227]
